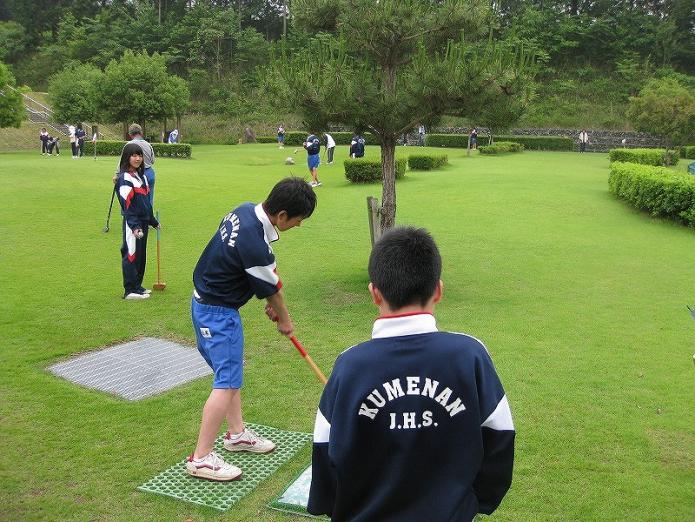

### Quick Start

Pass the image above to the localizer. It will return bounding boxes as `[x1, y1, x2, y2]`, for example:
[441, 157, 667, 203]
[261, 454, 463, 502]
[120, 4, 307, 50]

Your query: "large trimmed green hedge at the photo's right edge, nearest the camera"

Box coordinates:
[608, 161, 695, 227]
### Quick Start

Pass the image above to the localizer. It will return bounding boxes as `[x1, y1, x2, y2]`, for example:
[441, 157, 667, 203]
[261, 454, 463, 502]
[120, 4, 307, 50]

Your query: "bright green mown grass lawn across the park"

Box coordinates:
[0, 145, 695, 521]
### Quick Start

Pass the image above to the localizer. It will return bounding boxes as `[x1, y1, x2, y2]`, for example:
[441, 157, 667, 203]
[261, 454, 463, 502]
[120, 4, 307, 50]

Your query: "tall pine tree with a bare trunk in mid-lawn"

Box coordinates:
[268, 0, 530, 229]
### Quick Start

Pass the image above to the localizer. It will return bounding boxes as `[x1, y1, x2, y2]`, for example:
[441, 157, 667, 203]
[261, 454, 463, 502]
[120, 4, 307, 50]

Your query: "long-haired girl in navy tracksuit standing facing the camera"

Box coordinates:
[116, 143, 159, 300]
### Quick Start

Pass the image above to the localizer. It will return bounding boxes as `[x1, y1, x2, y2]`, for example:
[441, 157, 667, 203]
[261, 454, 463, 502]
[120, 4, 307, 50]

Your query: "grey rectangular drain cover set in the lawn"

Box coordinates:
[48, 337, 212, 401]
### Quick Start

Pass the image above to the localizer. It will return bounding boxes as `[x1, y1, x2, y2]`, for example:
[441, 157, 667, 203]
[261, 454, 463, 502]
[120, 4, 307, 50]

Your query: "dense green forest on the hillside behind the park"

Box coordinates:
[0, 0, 695, 137]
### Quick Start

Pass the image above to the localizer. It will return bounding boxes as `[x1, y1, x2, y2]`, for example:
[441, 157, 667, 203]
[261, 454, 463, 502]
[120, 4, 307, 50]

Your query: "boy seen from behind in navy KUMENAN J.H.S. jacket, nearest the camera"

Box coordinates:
[307, 227, 515, 522]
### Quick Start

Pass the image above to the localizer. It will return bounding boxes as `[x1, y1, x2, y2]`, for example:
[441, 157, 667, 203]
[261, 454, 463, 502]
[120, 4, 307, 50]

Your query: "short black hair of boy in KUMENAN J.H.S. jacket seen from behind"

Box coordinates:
[369, 227, 442, 310]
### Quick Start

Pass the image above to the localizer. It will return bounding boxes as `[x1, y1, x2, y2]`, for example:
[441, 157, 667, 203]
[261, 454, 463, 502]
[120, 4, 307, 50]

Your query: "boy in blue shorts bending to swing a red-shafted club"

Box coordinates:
[186, 178, 316, 481]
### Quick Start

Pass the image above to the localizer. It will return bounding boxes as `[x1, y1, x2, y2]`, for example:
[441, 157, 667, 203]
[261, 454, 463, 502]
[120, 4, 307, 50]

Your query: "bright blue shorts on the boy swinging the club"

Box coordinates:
[191, 298, 244, 389]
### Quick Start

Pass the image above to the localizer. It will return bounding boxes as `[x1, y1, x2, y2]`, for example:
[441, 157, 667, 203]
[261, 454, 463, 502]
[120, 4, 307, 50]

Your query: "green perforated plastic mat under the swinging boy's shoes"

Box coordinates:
[138, 424, 311, 511]
